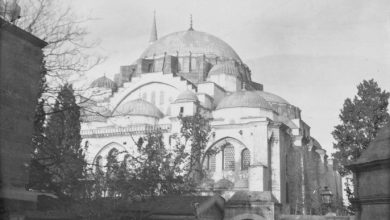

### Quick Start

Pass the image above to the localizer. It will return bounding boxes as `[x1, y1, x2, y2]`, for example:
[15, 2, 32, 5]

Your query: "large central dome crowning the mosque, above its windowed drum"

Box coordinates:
[141, 30, 241, 62]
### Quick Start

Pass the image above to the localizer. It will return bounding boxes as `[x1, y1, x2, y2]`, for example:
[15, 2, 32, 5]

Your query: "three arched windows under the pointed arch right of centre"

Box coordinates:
[206, 144, 250, 172]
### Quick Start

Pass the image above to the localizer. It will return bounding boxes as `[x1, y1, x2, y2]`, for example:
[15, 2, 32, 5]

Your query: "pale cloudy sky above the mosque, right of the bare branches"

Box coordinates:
[64, 0, 390, 155]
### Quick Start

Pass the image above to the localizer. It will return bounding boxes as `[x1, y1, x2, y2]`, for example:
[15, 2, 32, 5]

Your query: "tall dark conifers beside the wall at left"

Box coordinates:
[28, 85, 85, 198]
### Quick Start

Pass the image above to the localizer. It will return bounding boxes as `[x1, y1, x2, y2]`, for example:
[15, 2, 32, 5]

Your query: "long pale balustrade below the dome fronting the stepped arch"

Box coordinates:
[80, 124, 171, 138]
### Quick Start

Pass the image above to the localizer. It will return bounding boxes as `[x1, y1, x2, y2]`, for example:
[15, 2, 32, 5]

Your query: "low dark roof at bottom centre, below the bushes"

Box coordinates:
[125, 195, 221, 215]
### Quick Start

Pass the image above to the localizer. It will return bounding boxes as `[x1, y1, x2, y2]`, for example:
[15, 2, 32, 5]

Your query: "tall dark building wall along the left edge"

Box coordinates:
[0, 18, 46, 216]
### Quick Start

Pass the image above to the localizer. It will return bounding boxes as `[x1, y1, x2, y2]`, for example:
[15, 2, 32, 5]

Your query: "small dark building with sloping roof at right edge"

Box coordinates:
[348, 123, 390, 220]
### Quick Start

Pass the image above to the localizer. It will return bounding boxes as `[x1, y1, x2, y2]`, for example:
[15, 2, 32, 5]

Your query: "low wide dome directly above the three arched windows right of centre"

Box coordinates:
[217, 91, 273, 110]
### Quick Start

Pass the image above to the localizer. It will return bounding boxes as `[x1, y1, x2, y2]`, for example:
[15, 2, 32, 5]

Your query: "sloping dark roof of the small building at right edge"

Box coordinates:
[352, 123, 390, 165]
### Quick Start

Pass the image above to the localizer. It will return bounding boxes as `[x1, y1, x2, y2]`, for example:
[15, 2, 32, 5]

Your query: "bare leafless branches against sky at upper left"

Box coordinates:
[15, 0, 103, 88]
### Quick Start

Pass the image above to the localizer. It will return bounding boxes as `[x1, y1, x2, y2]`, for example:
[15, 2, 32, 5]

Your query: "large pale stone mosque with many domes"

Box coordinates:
[81, 14, 342, 219]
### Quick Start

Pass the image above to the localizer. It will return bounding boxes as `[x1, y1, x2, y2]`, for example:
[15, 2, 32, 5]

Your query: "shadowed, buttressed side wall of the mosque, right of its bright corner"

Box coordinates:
[285, 145, 342, 214]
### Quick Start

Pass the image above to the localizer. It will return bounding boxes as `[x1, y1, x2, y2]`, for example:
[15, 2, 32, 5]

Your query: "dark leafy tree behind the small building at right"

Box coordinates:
[332, 79, 390, 176]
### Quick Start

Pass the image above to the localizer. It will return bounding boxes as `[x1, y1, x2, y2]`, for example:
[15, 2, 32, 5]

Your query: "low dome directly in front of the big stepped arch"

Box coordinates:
[114, 99, 164, 118]
